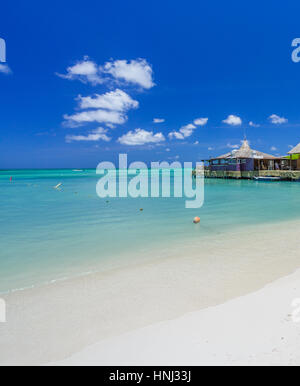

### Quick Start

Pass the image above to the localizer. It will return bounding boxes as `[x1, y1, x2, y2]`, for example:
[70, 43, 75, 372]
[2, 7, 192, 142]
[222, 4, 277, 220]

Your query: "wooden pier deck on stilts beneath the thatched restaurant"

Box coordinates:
[193, 170, 300, 181]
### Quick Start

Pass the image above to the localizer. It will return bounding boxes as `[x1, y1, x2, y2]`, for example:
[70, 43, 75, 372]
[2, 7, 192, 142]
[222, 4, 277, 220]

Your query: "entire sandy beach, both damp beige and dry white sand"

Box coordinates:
[0, 221, 300, 365]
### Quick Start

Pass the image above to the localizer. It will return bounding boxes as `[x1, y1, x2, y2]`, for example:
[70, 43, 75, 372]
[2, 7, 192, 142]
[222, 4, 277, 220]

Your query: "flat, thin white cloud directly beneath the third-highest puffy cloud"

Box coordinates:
[64, 109, 127, 127]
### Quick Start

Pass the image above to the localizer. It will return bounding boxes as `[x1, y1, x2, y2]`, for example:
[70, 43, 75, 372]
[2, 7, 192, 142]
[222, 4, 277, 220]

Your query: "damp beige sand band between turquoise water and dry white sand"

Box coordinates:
[0, 222, 300, 365]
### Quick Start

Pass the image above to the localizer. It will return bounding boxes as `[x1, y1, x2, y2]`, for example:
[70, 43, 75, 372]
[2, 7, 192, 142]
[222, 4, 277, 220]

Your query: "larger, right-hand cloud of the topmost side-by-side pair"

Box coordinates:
[100, 59, 155, 89]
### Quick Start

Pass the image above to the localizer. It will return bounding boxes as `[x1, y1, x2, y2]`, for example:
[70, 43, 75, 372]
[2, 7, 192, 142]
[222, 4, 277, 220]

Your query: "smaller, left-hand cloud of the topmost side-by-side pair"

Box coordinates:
[57, 57, 104, 85]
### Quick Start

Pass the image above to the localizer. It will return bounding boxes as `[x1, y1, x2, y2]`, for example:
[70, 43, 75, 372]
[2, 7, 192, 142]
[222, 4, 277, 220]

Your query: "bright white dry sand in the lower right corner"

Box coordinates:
[55, 270, 300, 366]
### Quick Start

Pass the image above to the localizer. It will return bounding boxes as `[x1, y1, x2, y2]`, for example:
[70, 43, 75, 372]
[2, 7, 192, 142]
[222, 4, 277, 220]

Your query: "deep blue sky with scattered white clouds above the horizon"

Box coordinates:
[0, 0, 300, 169]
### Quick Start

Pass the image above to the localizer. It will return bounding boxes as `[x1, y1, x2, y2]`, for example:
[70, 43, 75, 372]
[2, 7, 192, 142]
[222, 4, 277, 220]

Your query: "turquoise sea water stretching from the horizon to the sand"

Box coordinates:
[0, 170, 300, 293]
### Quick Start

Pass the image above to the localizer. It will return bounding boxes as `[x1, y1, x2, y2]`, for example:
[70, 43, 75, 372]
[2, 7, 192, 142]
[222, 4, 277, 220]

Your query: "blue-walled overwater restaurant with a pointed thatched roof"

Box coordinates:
[208, 140, 289, 172]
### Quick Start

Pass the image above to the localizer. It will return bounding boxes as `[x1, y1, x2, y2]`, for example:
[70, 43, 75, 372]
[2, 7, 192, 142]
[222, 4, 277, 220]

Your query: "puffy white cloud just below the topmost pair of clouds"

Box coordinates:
[78, 89, 139, 111]
